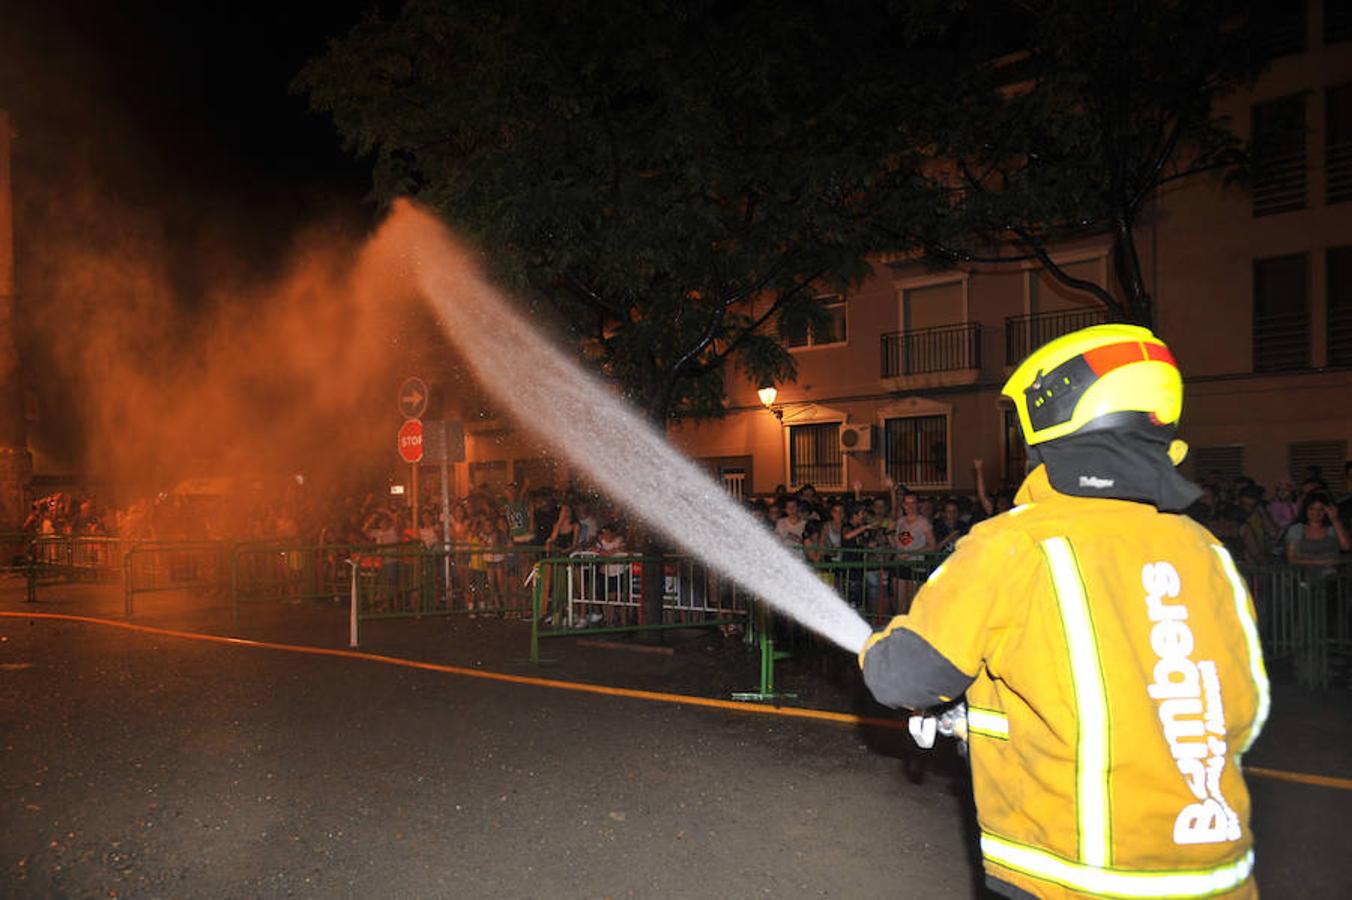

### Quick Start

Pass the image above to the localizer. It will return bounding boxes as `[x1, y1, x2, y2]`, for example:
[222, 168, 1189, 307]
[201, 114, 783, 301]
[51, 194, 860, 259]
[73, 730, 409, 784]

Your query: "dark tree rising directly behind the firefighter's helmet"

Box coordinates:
[892, 0, 1253, 324]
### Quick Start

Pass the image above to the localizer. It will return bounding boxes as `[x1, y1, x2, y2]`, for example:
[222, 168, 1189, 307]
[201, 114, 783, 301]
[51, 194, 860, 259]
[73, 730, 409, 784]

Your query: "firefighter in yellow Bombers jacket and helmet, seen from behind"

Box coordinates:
[859, 324, 1268, 897]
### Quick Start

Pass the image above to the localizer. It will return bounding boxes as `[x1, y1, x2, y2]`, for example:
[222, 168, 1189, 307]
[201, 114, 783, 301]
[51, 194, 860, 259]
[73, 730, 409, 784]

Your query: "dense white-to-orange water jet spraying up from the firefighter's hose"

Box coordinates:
[377, 203, 871, 653]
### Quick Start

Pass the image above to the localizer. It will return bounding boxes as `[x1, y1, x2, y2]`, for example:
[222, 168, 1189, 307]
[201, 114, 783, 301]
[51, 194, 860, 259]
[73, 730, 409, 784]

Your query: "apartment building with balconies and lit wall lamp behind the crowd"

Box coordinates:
[448, 0, 1352, 495]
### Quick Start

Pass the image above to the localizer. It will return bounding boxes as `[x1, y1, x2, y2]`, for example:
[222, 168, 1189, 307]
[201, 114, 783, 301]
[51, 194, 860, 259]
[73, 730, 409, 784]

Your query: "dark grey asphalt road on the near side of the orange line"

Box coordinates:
[0, 618, 1352, 899]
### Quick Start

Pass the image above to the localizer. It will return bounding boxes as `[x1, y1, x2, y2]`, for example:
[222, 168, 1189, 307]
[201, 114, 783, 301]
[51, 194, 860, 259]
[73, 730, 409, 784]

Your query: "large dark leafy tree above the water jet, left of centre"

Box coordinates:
[297, 0, 930, 423]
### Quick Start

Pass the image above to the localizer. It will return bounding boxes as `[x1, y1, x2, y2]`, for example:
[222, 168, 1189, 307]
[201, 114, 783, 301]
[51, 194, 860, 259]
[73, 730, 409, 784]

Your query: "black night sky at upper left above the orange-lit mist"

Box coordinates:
[0, 0, 372, 263]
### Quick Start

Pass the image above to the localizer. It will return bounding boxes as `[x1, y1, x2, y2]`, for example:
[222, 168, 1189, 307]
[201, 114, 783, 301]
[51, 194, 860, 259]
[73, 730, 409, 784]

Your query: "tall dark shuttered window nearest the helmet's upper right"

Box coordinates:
[1253, 253, 1310, 372]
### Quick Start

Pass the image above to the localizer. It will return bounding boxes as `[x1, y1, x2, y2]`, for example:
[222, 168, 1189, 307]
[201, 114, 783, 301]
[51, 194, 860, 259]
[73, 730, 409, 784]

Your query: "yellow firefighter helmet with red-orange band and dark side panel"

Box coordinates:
[1000, 324, 1186, 448]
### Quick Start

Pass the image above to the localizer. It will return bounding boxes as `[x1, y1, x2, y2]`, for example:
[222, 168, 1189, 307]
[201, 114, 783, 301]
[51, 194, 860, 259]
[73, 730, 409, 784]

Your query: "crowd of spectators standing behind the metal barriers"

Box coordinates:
[15, 459, 1352, 572]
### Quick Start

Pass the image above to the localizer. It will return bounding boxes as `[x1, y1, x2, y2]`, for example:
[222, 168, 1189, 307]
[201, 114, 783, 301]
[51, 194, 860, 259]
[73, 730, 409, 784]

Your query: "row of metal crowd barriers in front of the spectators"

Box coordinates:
[10, 534, 1352, 686]
